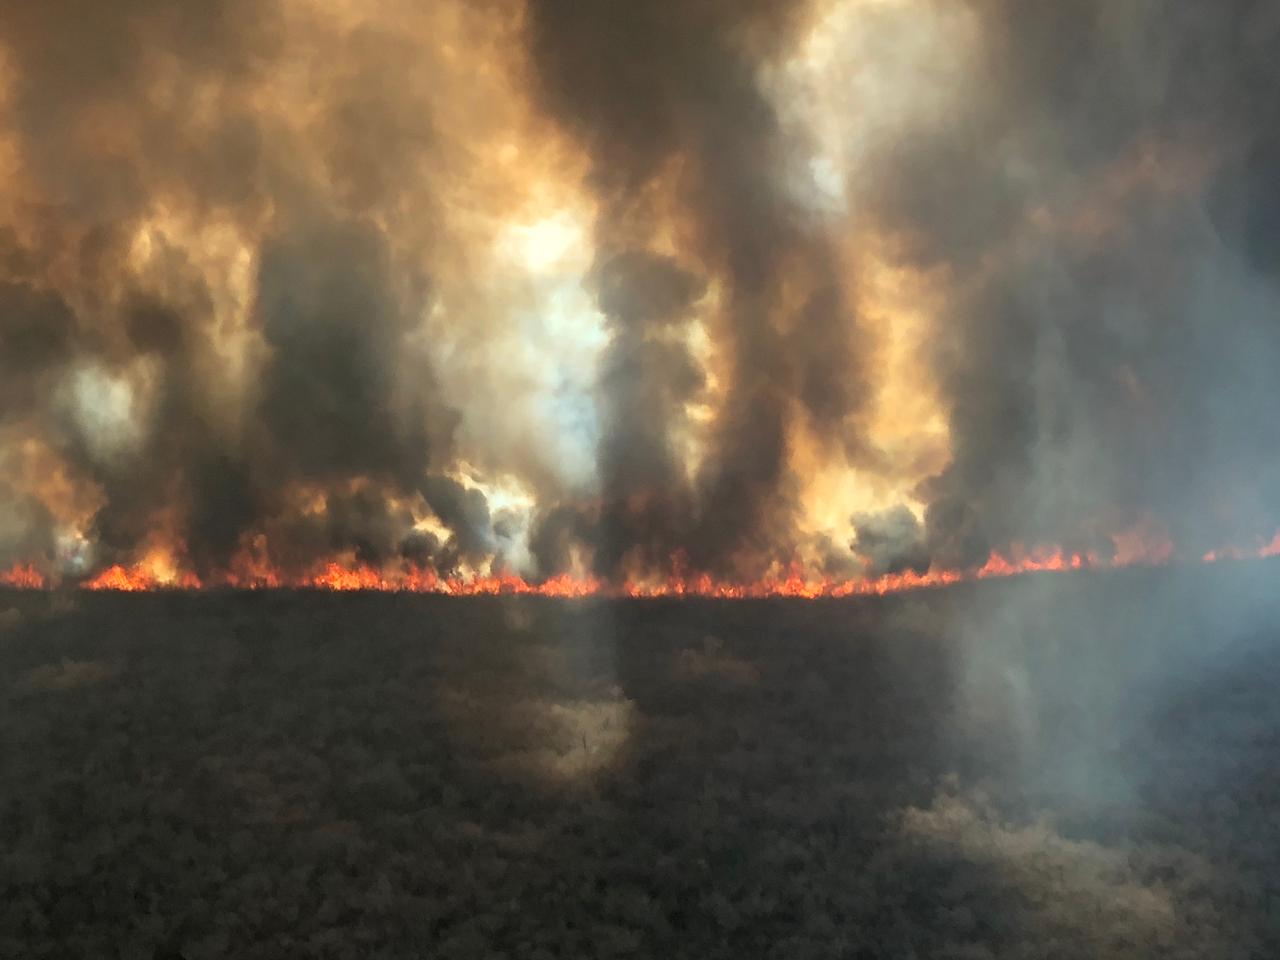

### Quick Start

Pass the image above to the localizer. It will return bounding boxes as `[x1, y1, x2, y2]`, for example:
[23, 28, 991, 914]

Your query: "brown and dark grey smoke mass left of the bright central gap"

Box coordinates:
[0, 0, 476, 575]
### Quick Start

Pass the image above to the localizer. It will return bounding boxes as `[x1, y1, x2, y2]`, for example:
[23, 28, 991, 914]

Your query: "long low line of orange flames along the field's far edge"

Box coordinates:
[0, 531, 1280, 599]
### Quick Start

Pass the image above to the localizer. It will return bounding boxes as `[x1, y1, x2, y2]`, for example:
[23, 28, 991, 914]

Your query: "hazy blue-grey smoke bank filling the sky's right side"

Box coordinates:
[874, 3, 1280, 563]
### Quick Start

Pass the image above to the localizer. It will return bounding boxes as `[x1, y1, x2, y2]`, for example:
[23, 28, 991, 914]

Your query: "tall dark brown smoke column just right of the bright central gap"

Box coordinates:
[530, 0, 860, 570]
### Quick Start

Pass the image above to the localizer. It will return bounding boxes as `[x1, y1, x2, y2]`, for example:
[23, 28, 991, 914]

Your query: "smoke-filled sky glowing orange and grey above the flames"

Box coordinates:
[0, 0, 1280, 577]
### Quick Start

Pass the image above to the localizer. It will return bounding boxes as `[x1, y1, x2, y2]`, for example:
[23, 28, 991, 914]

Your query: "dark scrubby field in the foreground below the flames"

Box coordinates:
[0, 563, 1280, 960]
